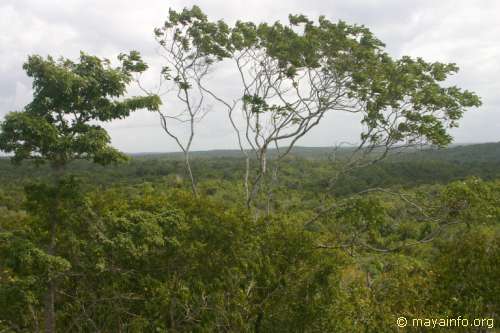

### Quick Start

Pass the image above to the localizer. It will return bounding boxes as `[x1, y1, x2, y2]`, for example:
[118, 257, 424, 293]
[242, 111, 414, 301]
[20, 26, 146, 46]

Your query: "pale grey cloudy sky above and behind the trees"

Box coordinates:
[0, 0, 500, 152]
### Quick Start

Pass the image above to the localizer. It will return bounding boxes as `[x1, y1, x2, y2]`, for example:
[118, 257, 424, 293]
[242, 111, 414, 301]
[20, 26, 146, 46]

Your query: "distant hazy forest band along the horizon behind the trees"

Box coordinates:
[0, 143, 500, 195]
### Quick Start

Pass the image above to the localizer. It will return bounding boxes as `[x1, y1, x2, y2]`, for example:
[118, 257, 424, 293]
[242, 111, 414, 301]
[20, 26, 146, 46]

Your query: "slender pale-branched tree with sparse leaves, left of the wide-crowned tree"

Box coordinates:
[125, 6, 234, 196]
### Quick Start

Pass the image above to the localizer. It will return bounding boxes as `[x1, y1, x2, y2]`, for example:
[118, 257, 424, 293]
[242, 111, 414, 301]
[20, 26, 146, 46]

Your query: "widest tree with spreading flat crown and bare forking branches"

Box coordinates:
[155, 6, 480, 211]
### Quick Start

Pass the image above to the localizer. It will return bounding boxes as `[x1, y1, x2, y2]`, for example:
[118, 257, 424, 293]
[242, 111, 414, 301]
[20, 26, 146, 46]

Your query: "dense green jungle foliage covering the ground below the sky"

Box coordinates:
[0, 144, 500, 332]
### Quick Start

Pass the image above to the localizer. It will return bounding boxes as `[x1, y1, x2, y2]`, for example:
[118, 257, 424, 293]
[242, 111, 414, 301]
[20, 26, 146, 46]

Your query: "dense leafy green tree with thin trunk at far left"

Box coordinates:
[0, 53, 160, 332]
